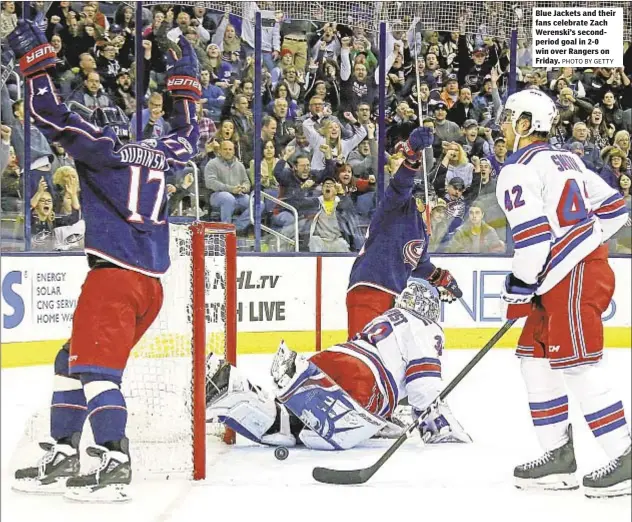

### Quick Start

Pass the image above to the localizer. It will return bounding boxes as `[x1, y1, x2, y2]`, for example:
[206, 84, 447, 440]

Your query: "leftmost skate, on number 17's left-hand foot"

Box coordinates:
[12, 433, 81, 495]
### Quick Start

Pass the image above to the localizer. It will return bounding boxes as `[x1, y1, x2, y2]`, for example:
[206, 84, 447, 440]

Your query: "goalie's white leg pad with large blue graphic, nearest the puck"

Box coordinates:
[277, 357, 386, 450]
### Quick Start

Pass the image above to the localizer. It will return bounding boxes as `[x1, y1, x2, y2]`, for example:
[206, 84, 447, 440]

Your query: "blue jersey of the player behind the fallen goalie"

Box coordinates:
[349, 163, 435, 295]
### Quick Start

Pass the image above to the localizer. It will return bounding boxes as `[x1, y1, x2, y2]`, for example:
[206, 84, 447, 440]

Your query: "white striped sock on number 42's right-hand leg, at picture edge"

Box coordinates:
[564, 361, 630, 459]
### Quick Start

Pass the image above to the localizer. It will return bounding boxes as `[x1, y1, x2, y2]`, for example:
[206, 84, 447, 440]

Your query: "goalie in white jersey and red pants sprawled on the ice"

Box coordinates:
[207, 282, 471, 450]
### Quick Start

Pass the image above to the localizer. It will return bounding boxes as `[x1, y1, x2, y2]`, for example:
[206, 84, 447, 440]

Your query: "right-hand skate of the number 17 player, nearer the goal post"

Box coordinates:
[64, 438, 132, 502]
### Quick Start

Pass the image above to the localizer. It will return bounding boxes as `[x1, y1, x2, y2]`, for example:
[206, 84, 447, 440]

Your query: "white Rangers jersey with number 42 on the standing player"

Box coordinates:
[496, 142, 627, 295]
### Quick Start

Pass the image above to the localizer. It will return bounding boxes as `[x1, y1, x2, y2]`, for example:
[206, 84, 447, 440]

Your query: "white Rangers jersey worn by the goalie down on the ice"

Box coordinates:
[327, 308, 445, 417]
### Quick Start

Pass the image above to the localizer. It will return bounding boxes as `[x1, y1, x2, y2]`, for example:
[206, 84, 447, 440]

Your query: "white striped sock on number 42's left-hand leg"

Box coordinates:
[520, 357, 568, 451]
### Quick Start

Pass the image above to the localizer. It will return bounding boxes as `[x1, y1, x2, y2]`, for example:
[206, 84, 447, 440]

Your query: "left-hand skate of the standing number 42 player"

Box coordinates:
[514, 424, 579, 491]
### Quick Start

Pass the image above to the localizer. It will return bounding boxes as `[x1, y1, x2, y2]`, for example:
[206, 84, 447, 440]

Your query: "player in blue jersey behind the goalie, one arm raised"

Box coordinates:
[347, 127, 463, 339]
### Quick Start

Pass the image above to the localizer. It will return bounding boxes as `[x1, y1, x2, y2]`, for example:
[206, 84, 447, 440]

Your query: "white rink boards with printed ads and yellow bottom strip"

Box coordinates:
[1, 255, 632, 367]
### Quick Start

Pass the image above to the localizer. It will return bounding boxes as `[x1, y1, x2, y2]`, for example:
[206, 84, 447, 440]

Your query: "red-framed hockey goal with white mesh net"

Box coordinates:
[16, 223, 237, 479]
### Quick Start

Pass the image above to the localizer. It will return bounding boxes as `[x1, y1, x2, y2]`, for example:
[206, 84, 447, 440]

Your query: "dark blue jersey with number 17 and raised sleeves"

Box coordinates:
[29, 74, 199, 277]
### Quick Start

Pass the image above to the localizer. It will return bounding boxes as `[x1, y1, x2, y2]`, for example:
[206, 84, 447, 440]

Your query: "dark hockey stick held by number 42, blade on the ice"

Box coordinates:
[312, 319, 516, 484]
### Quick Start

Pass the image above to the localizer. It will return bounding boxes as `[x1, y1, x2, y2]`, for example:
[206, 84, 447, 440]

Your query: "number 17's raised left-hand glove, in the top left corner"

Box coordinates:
[7, 20, 57, 77]
